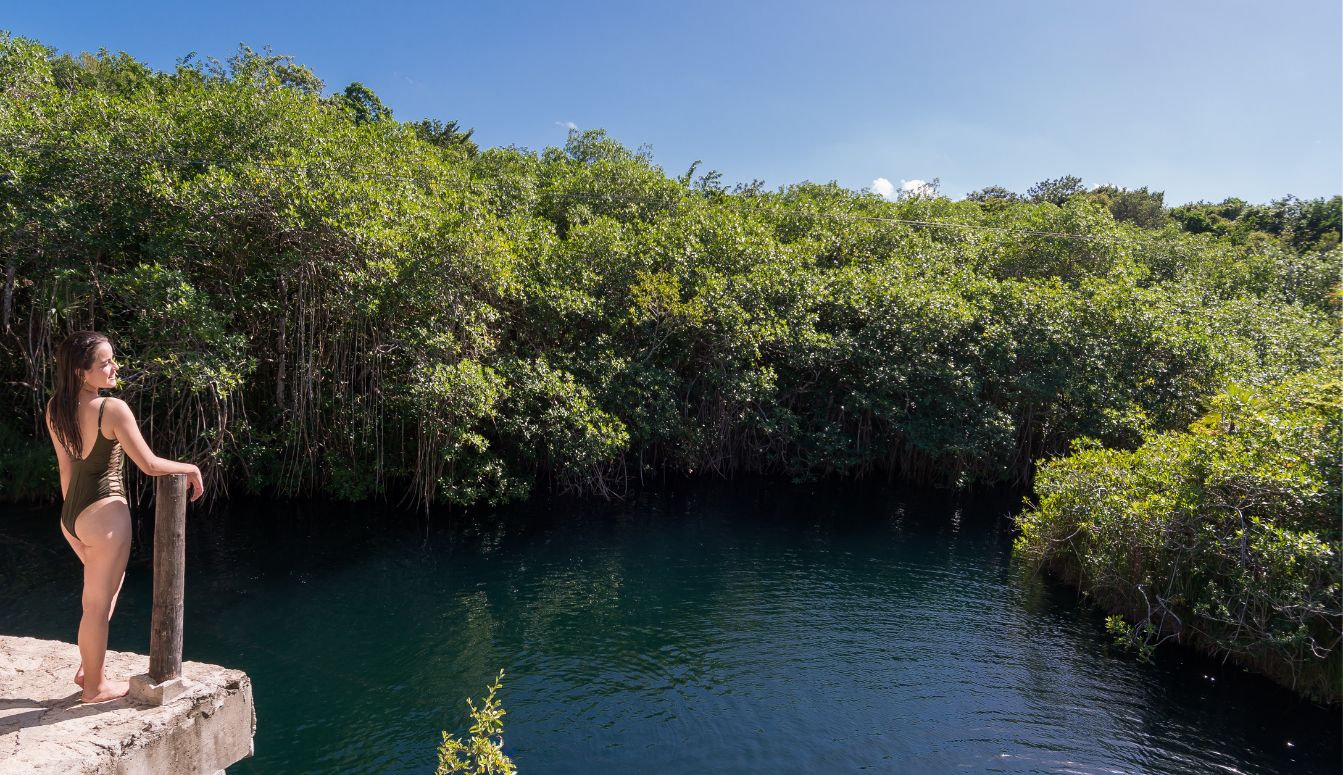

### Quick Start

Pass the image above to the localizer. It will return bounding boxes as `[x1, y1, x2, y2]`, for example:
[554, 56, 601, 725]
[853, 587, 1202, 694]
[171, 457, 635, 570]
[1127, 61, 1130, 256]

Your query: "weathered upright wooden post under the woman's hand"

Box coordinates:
[130, 474, 187, 705]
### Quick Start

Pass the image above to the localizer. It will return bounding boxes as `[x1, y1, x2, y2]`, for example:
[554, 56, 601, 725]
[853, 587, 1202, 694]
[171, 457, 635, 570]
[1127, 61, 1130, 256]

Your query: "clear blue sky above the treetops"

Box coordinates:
[0, 0, 1343, 204]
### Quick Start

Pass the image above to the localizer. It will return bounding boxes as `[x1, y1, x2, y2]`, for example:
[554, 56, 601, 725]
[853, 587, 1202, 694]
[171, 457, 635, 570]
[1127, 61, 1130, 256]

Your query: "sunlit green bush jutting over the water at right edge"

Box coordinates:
[1018, 363, 1343, 701]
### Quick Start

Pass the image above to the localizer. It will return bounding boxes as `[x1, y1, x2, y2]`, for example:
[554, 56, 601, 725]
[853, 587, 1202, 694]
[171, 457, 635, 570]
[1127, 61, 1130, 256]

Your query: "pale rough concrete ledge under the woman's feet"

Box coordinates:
[0, 635, 257, 775]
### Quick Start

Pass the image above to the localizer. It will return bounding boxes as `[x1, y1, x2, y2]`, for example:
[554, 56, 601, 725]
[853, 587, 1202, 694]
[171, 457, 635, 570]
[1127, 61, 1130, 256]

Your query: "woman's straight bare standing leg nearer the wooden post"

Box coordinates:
[75, 500, 130, 702]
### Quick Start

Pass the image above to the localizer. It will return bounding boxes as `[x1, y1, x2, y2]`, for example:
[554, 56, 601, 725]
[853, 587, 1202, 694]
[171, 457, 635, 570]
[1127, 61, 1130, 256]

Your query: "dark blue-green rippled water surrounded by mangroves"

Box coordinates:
[0, 482, 1340, 775]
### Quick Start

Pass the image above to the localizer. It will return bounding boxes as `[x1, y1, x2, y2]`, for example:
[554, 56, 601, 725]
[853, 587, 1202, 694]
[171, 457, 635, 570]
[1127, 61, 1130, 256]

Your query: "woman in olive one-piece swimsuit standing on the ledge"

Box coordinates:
[47, 330, 205, 702]
